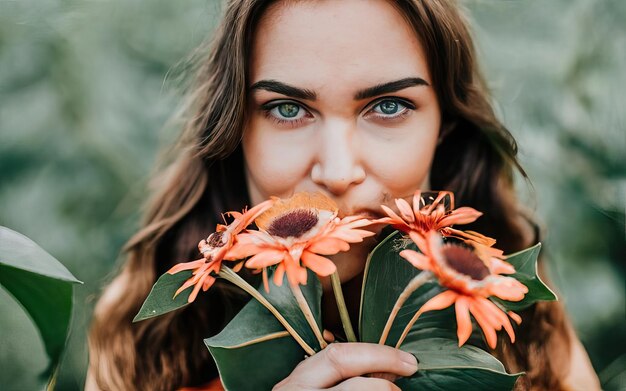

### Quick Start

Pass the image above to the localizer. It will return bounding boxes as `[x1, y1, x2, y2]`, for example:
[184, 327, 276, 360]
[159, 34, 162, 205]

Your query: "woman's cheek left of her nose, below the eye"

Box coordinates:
[242, 120, 312, 202]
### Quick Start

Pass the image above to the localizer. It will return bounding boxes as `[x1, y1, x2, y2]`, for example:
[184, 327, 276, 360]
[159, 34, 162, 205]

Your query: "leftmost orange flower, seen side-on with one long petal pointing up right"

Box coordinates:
[167, 200, 274, 303]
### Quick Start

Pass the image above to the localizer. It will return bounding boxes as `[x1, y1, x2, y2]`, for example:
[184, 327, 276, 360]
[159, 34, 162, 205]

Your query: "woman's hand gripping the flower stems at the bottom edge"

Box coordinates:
[274, 343, 417, 391]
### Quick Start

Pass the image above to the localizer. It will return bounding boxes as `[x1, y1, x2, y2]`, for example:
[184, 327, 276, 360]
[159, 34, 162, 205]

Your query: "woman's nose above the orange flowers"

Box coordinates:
[311, 121, 366, 195]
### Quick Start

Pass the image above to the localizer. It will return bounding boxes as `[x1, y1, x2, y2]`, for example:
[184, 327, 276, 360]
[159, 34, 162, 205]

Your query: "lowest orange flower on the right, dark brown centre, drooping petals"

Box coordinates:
[400, 231, 528, 349]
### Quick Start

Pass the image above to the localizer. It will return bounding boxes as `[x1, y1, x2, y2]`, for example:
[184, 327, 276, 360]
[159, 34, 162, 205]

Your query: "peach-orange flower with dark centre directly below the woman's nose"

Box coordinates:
[232, 193, 374, 290]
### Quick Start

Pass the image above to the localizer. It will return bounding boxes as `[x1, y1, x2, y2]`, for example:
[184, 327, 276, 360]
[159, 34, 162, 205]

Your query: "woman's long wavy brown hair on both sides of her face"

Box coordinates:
[89, 0, 569, 390]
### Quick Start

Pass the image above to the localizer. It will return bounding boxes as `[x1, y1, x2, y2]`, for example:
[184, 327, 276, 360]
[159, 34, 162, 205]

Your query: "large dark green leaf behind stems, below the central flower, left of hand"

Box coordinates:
[204, 272, 322, 390]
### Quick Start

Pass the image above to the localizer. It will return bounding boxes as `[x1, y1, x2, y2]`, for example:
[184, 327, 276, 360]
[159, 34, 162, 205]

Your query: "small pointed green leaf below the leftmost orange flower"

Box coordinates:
[133, 270, 193, 322]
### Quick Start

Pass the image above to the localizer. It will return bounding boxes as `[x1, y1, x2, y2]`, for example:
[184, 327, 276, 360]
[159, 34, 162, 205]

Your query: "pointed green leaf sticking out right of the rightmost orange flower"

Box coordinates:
[493, 243, 557, 311]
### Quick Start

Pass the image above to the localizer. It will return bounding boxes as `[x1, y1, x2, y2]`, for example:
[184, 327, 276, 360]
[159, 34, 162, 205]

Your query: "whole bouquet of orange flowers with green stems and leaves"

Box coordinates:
[135, 191, 556, 390]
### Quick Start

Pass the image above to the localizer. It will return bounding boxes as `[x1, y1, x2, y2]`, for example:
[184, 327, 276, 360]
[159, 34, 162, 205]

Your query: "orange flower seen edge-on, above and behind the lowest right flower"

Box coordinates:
[377, 190, 496, 246]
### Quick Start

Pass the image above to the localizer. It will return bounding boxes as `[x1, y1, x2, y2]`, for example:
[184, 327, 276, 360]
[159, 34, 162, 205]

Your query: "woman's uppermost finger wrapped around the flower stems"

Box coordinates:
[289, 343, 417, 388]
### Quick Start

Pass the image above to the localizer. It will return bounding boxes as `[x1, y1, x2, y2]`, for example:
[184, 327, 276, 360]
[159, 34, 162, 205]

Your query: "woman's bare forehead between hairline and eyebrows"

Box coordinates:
[250, 0, 430, 89]
